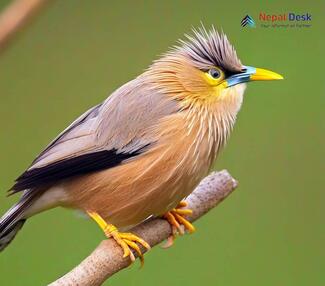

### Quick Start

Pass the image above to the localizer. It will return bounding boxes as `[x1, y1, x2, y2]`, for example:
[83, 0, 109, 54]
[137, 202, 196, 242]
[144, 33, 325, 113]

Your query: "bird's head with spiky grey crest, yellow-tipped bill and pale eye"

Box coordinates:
[146, 26, 283, 109]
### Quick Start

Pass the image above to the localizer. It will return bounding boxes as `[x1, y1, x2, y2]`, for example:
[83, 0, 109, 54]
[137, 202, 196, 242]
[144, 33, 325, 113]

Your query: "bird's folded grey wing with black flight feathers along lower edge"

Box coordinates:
[11, 79, 179, 193]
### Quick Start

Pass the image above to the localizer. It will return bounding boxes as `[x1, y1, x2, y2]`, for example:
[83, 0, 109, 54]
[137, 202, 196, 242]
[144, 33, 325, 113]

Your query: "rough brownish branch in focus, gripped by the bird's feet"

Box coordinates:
[50, 170, 237, 286]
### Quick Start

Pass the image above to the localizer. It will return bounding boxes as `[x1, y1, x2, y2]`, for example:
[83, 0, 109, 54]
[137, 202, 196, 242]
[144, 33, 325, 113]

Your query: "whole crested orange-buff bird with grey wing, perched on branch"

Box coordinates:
[0, 25, 283, 262]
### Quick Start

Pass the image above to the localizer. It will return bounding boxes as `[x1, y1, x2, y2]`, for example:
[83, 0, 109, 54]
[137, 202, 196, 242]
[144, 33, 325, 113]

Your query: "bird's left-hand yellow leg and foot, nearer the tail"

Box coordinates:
[87, 211, 150, 265]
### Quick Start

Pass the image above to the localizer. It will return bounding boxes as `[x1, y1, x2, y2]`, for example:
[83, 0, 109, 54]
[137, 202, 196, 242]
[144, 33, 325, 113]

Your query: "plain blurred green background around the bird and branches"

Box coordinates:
[0, 0, 325, 286]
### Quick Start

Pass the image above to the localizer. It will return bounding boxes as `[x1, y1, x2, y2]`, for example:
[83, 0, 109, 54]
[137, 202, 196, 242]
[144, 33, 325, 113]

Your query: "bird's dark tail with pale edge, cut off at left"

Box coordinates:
[0, 191, 36, 251]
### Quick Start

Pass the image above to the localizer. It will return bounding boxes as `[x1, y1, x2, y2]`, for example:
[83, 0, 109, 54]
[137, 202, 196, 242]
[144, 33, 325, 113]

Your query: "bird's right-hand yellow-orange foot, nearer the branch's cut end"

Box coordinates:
[163, 201, 195, 248]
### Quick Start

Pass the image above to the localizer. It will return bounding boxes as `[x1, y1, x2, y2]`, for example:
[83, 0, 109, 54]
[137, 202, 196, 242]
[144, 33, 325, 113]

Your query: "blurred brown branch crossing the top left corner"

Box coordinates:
[0, 0, 48, 50]
